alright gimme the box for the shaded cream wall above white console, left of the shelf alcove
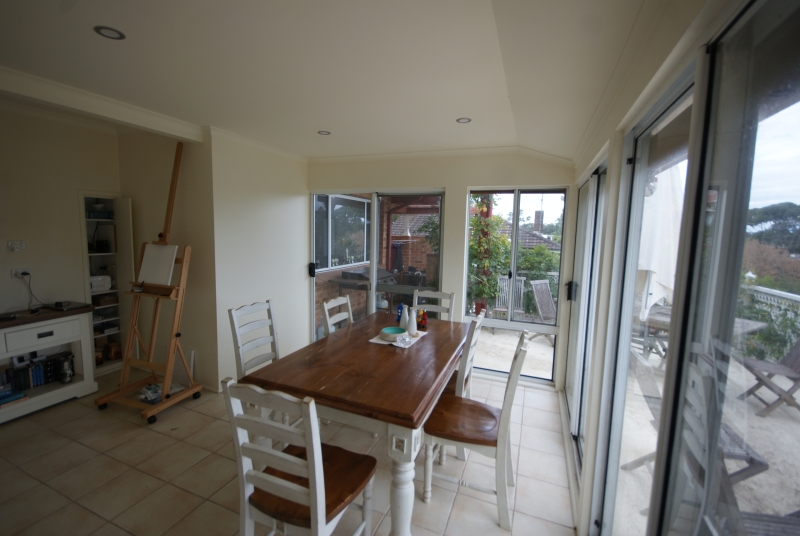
[0,103,120,311]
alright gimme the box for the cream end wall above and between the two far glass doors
[308,150,574,324]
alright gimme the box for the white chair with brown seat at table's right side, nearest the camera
[422,331,528,530]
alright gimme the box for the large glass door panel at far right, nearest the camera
[663,2,800,535]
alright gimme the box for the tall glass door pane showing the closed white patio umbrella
[606,95,692,536]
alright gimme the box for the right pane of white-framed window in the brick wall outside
[331,197,367,266]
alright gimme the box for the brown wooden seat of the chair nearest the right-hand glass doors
[425,395,501,447]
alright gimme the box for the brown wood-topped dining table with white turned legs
[241,312,469,536]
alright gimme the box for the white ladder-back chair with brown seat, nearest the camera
[222,378,377,536]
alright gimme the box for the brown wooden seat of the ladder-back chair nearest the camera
[249,443,378,528]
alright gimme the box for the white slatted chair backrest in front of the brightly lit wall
[228,300,280,379]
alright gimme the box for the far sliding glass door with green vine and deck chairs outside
[465,190,566,380]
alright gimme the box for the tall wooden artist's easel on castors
[94,142,203,424]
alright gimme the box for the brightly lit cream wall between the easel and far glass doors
[211,129,311,384]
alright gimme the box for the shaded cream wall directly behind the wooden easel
[119,129,219,390]
